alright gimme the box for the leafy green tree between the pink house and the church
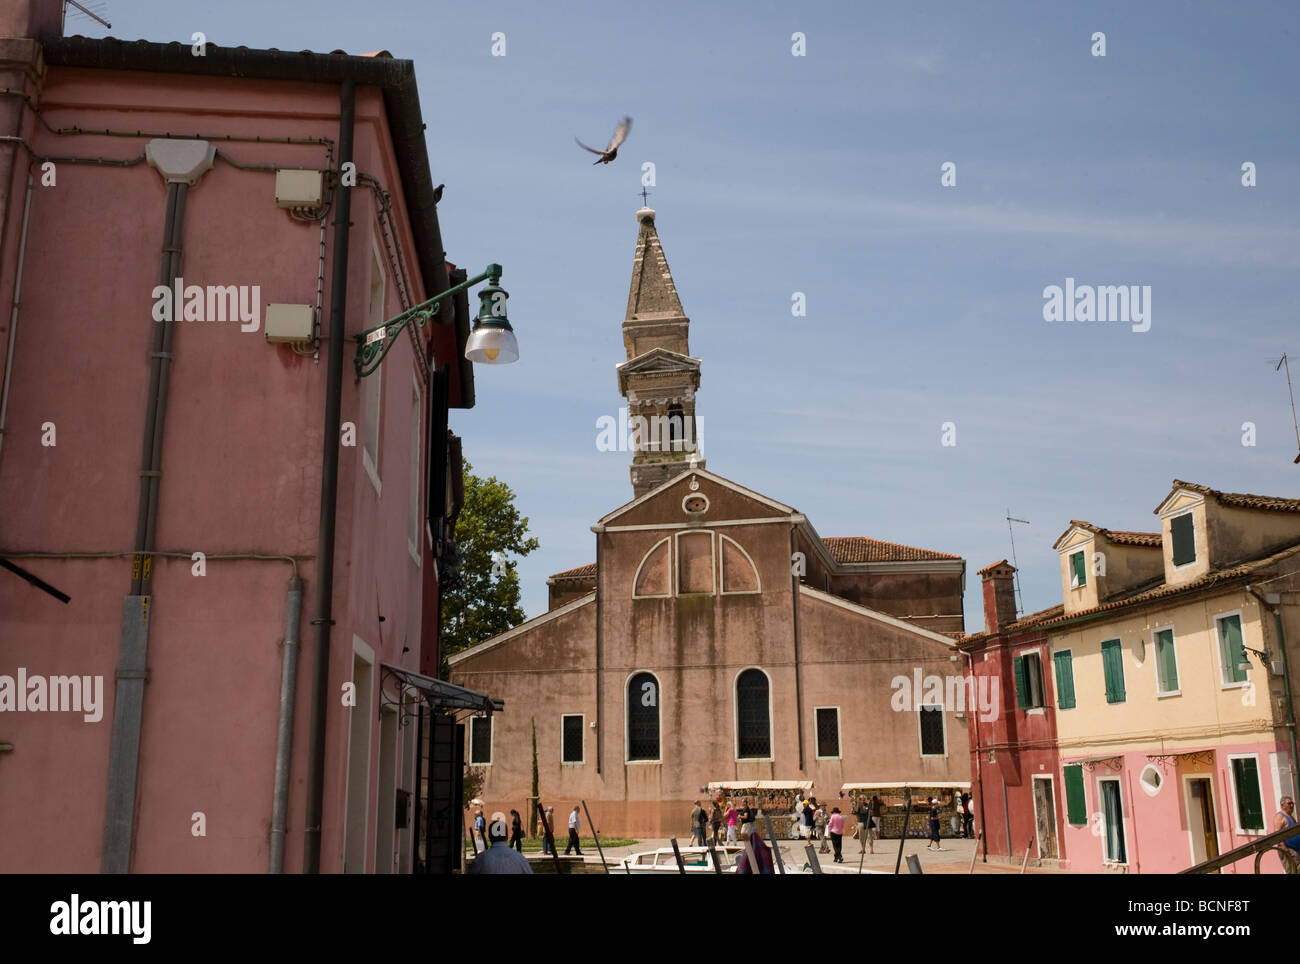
[442,461,538,659]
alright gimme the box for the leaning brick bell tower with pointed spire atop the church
[618,208,705,498]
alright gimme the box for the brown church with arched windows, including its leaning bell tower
[449,208,970,837]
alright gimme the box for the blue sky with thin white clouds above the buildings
[83,0,1300,631]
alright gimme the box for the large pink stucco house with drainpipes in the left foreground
[0,0,494,873]
